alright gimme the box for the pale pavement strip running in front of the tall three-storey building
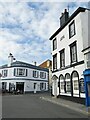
[41,95,90,118]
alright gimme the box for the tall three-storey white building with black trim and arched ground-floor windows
[50,7,90,101]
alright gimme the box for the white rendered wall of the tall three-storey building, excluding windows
[51,11,88,97]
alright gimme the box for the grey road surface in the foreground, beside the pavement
[2,94,87,118]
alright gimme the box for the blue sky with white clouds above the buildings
[0,0,87,66]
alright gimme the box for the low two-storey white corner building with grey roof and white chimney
[0,53,48,93]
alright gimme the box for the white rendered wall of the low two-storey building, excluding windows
[0,67,48,92]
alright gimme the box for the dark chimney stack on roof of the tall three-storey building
[60,9,69,27]
